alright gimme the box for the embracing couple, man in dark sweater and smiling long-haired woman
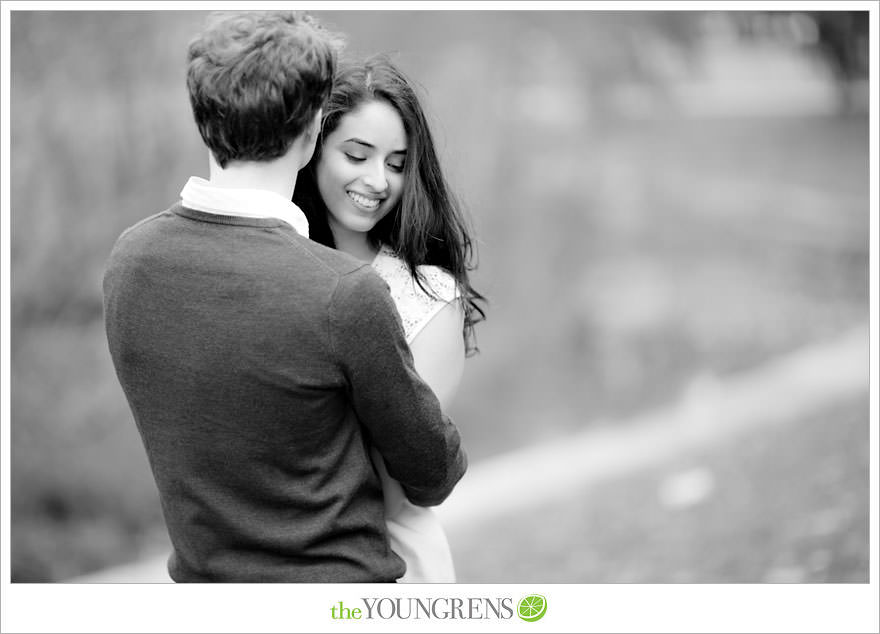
[104,12,483,582]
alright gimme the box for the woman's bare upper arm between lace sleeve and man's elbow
[410,301,464,411]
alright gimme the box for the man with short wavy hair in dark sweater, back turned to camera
[104,12,466,582]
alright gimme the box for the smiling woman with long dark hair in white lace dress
[293,57,485,583]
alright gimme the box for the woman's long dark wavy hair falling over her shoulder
[293,55,486,356]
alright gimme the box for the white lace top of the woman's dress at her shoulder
[373,245,461,343]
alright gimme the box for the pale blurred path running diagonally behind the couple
[72,325,869,583]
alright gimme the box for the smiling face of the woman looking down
[317,101,407,242]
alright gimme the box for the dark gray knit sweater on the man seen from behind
[104,205,466,582]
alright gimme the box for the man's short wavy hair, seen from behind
[186,11,342,167]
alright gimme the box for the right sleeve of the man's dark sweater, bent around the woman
[329,266,467,506]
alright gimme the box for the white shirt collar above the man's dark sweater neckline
[180,176,309,238]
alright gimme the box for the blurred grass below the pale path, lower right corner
[449,402,870,583]
